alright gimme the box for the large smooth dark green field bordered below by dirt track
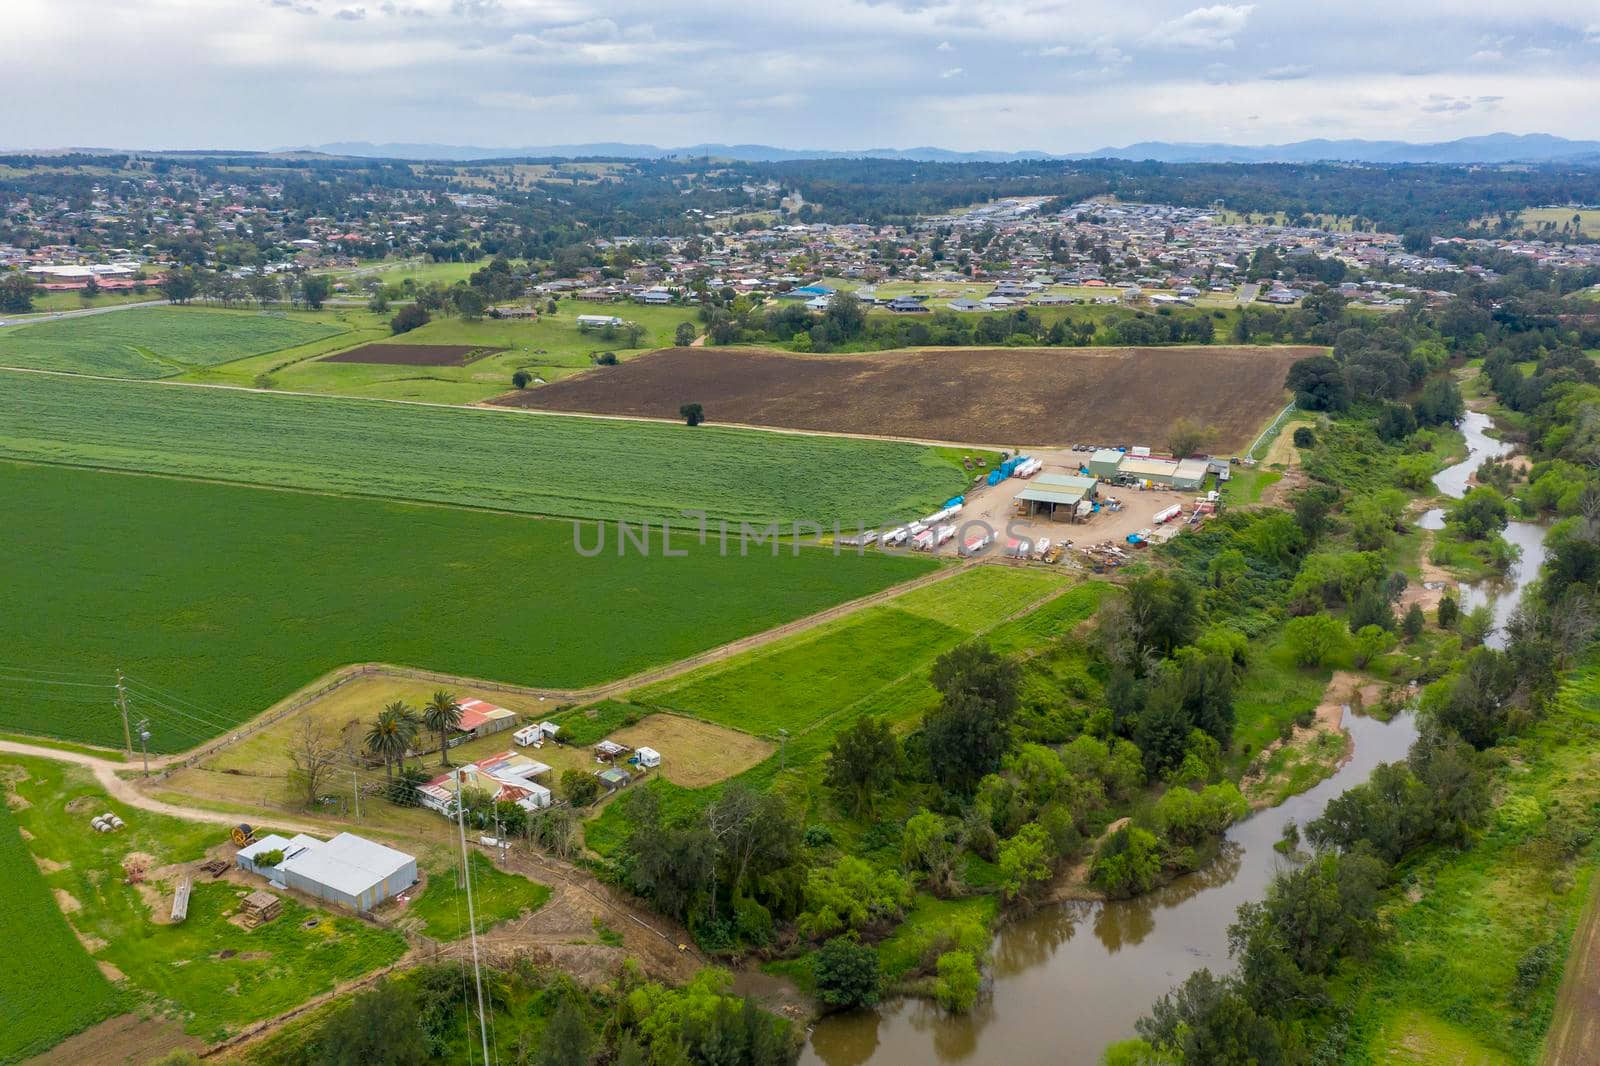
[0,464,938,751]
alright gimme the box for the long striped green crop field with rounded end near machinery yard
[0,373,966,521]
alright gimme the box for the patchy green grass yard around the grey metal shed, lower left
[4,759,406,1039]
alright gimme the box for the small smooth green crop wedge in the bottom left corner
[0,787,122,1063]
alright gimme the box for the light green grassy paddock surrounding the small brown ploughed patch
[182,300,694,403]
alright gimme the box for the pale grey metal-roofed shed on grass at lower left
[235,832,416,911]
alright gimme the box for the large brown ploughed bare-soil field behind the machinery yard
[493,346,1322,451]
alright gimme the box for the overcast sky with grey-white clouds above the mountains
[9,0,1600,152]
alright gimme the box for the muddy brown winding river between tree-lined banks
[800,403,1544,1066]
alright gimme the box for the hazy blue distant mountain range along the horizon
[302,133,1600,165]
